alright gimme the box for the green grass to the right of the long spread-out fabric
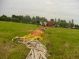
[45,28,79,59]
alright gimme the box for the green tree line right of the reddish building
[50,18,79,29]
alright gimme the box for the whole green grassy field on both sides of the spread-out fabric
[0,22,79,59]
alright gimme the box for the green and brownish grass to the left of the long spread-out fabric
[0,22,38,59]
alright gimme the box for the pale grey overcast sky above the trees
[0,0,79,24]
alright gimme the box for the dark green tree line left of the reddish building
[0,15,47,25]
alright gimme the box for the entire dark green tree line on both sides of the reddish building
[0,15,79,29]
